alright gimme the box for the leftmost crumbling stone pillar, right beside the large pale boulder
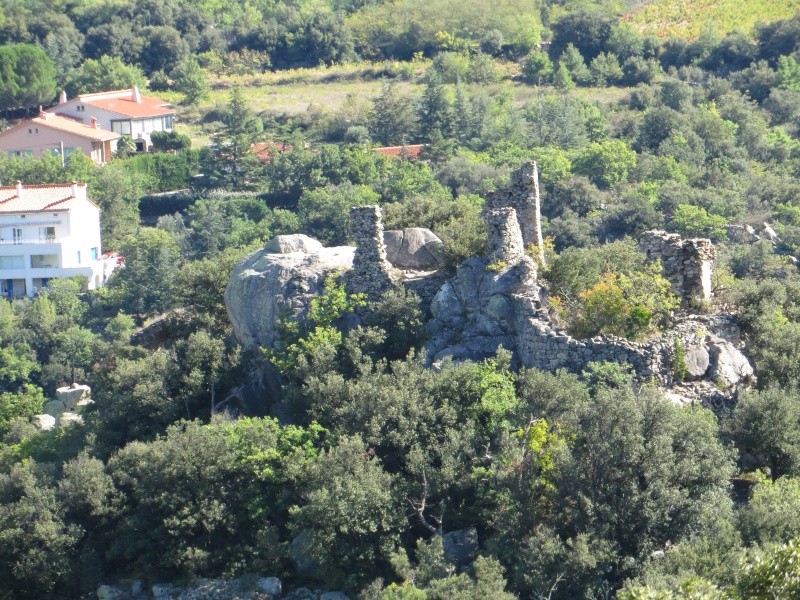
[346,206,392,298]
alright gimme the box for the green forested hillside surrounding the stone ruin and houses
[0,0,800,600]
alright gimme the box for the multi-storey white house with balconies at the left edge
[0,181,117,298]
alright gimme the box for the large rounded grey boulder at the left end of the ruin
[225,246,355,348]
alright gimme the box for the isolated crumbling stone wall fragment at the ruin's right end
[639,231,716,308]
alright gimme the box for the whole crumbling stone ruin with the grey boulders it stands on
[226,164,753,396]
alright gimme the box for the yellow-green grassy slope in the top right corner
[625,0,800,38]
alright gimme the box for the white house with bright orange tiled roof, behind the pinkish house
[47,86,175,152]
